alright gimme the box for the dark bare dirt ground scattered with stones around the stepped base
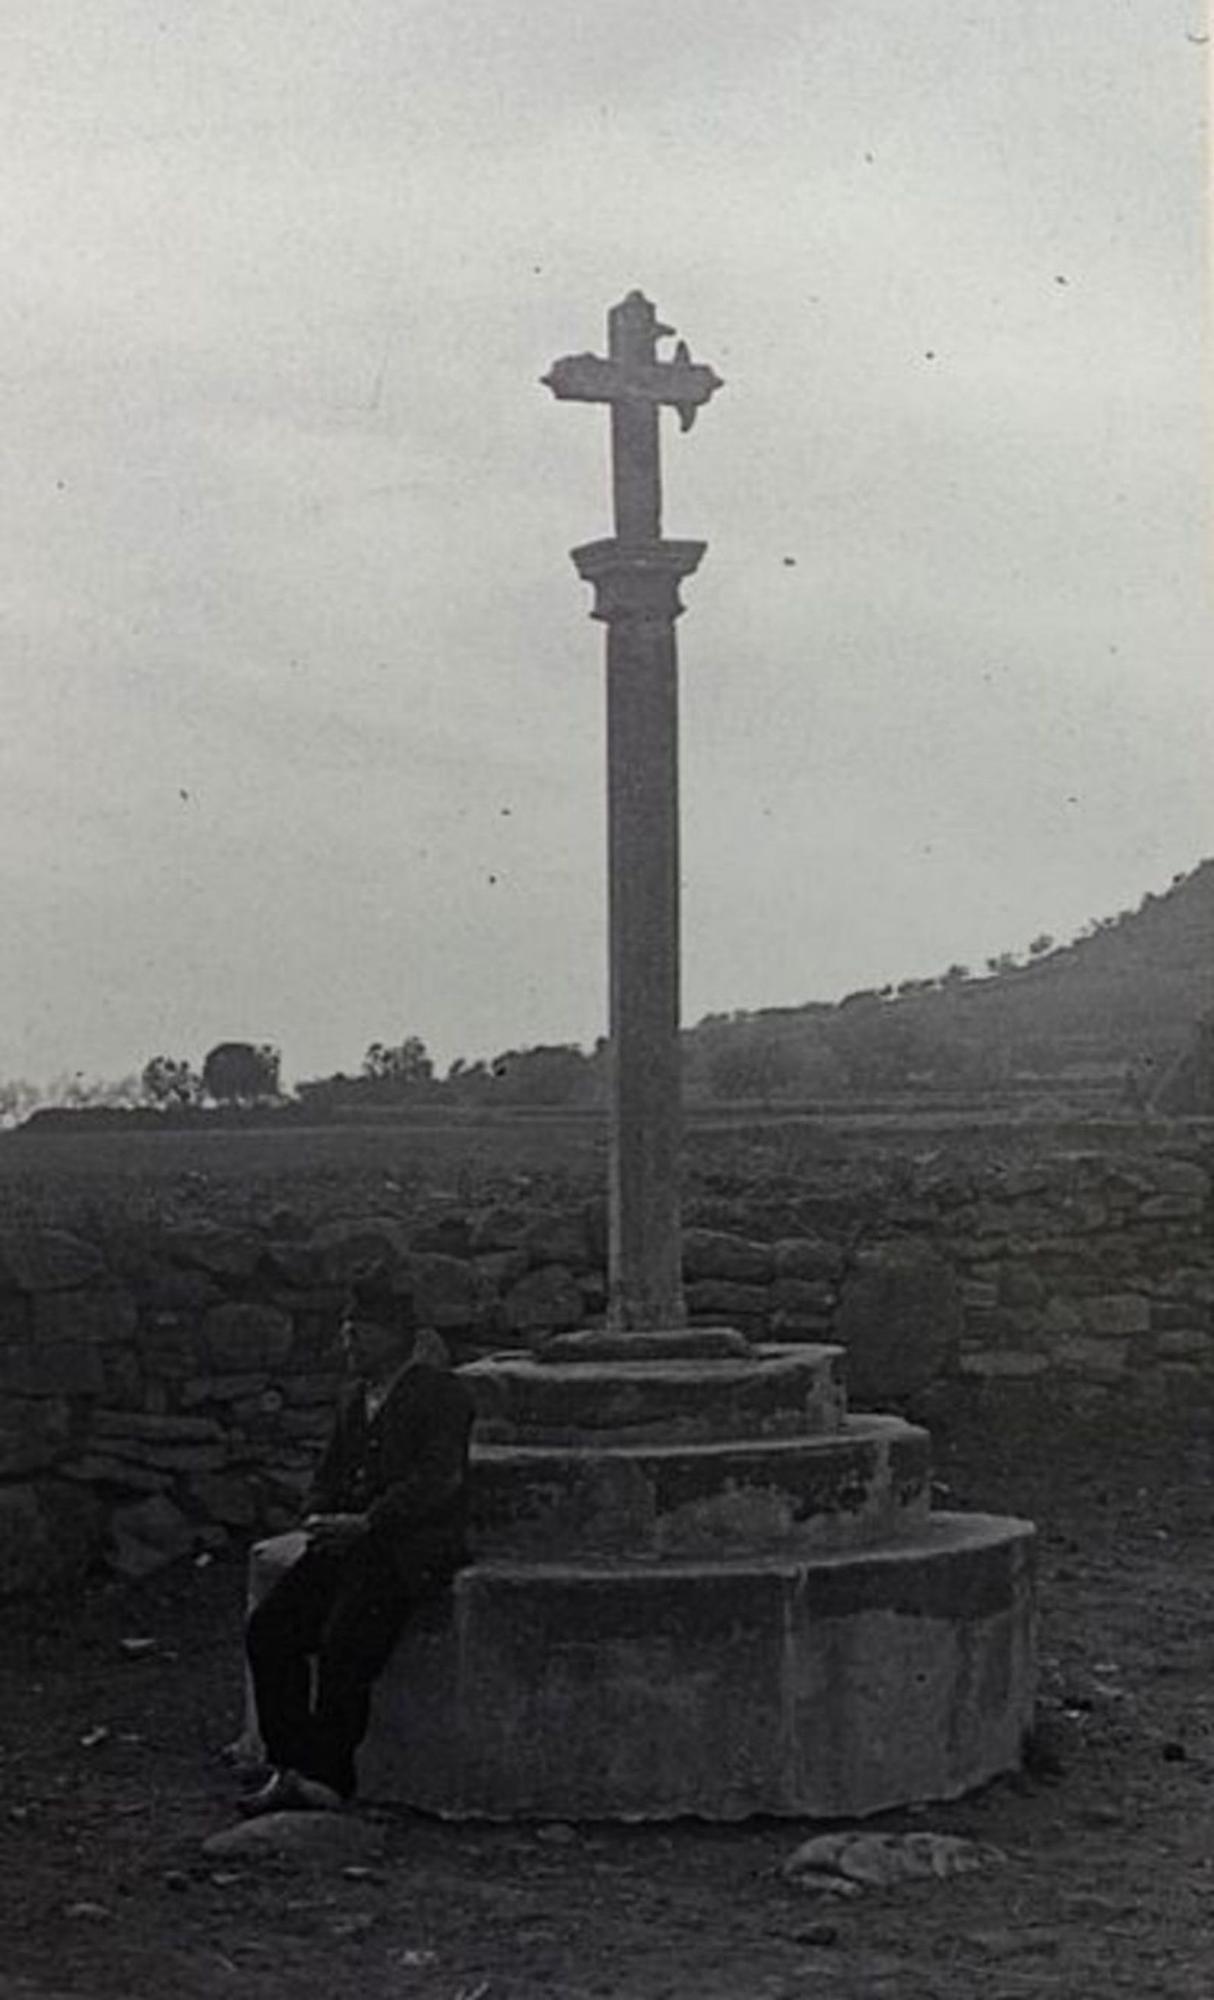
[0,1424,1214,2000]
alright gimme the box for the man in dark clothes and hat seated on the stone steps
[242,1276,474,1812]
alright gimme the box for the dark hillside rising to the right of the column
[688,860,1214,1096]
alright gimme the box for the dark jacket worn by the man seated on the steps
[308,1362,474,1580]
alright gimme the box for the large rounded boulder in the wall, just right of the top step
[834,1242,962,1406]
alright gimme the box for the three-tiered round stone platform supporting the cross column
[254,1328,1034,1820]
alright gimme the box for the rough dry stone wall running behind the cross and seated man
[0,1140,1214,1594]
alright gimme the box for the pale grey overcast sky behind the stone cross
[0,0,1214,1076]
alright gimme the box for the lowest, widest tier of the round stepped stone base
[360,1514,1034,1820]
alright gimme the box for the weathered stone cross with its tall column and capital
[544,292,722,1332]
